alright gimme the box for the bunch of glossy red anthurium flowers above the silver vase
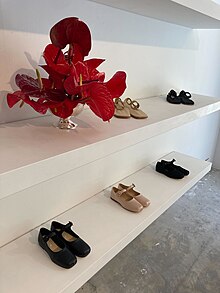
[7,17,126,121]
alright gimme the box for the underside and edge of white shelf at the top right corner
[91,0,220,29]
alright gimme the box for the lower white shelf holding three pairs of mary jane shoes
[0,152,211,293]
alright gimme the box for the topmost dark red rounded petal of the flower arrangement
[50,17,91,56]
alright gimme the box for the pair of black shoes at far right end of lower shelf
[156,159,189,179]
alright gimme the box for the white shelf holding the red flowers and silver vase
[0,95,220,199]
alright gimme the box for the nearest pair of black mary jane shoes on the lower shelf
[38,221,91,269]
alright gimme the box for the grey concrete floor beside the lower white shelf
[77,170,220,293]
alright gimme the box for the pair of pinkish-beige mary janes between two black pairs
[111,183,150,213]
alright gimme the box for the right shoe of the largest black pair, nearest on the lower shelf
[51,221,91,257]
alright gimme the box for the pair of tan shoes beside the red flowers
[114,98,148,119]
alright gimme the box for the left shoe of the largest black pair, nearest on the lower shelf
[38,228,77,269]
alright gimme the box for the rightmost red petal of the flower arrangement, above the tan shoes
[105,71,126,99]
